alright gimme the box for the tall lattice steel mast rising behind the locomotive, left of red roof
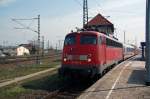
[83,0,88,28]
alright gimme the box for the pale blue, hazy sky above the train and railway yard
[0,0,146,46]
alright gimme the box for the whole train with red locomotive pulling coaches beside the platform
[58,31,135,78]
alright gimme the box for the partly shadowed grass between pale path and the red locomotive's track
[0,71,62,99]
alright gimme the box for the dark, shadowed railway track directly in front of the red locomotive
[42,81,93,99]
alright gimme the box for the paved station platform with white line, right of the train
[78,55,150,99]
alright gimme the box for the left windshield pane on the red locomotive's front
[64,35,76,45]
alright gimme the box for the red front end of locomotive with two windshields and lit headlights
[59,32,98,77]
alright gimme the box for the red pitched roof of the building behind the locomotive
[88,14,113,25]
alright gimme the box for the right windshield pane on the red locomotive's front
[80,35,97,44]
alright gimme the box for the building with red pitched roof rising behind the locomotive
[85,14,114,35]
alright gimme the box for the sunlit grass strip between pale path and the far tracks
[0,58,60,82]
